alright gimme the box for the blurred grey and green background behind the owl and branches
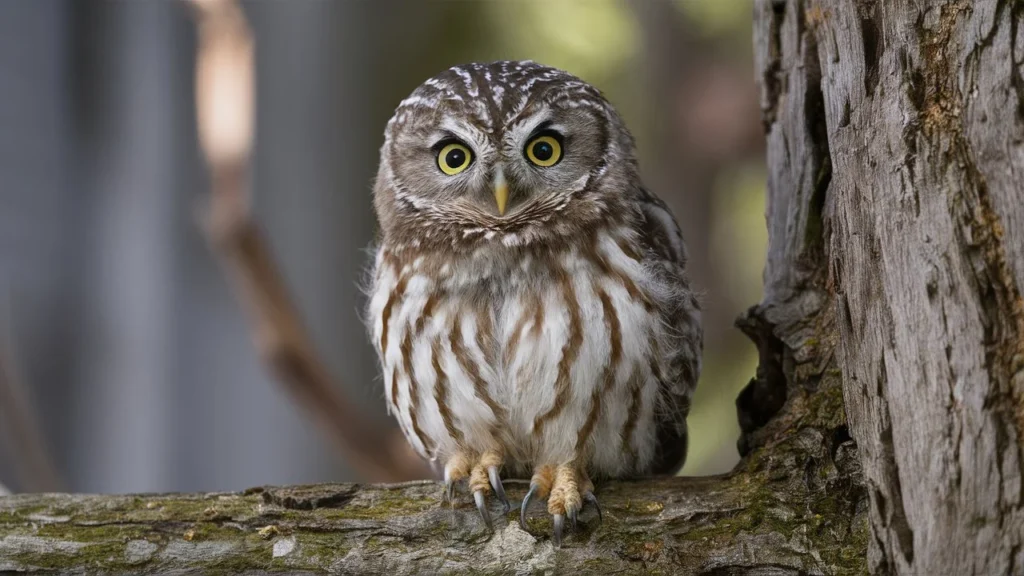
[0,0,766,492]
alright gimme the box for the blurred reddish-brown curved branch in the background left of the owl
[191,0,431,482]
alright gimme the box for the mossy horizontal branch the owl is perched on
[0,409,867,576]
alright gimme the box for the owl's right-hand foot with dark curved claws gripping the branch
[519,464,603,547]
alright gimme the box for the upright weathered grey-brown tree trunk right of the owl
[756,0,1024,574]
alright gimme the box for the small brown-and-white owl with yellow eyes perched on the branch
[367,61,702,545]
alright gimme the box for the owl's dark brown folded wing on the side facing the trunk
[640,186,703,475]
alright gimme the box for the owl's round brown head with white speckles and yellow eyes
[374,61,639,249]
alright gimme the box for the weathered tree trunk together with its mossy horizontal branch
[0,0,1024,575]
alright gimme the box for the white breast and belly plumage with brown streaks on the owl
[369,228,669,476]
